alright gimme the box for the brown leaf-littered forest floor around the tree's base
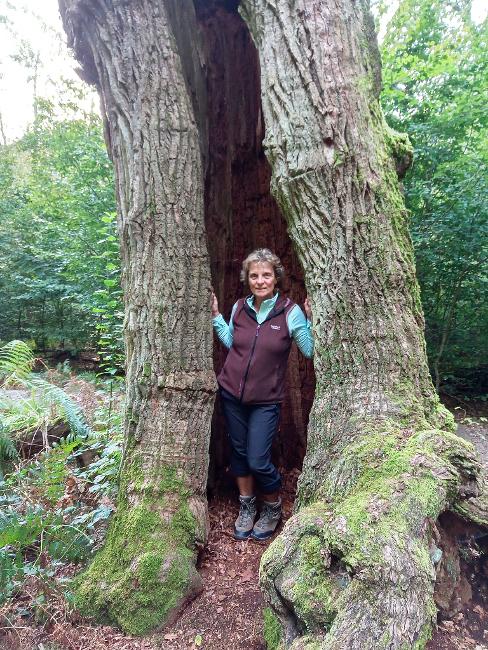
[0,404,488,650]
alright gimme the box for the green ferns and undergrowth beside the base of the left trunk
[0,350,122,627]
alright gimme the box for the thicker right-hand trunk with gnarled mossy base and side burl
[240,0,488,650]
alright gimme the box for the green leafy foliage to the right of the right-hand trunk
[382,0,488,393]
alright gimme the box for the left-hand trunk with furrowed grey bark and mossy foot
[60,0,216,633]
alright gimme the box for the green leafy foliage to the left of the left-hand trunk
[0,89,122,362]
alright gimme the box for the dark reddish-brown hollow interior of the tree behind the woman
[191,0,314,487]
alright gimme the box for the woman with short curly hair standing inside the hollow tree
[212,248,313,540]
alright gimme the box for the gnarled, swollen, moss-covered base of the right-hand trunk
[260,412,479,650]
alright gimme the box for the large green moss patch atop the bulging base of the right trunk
[312,425,457,572]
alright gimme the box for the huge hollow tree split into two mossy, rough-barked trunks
[60,0,487,650]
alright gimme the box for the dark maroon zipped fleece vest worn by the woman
[217,296,295,404]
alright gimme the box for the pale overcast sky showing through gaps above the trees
[0,0,488,141]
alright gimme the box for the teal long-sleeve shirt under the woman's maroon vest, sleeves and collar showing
[212,294,313,359]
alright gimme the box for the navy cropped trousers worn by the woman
[220,388,281,494]
